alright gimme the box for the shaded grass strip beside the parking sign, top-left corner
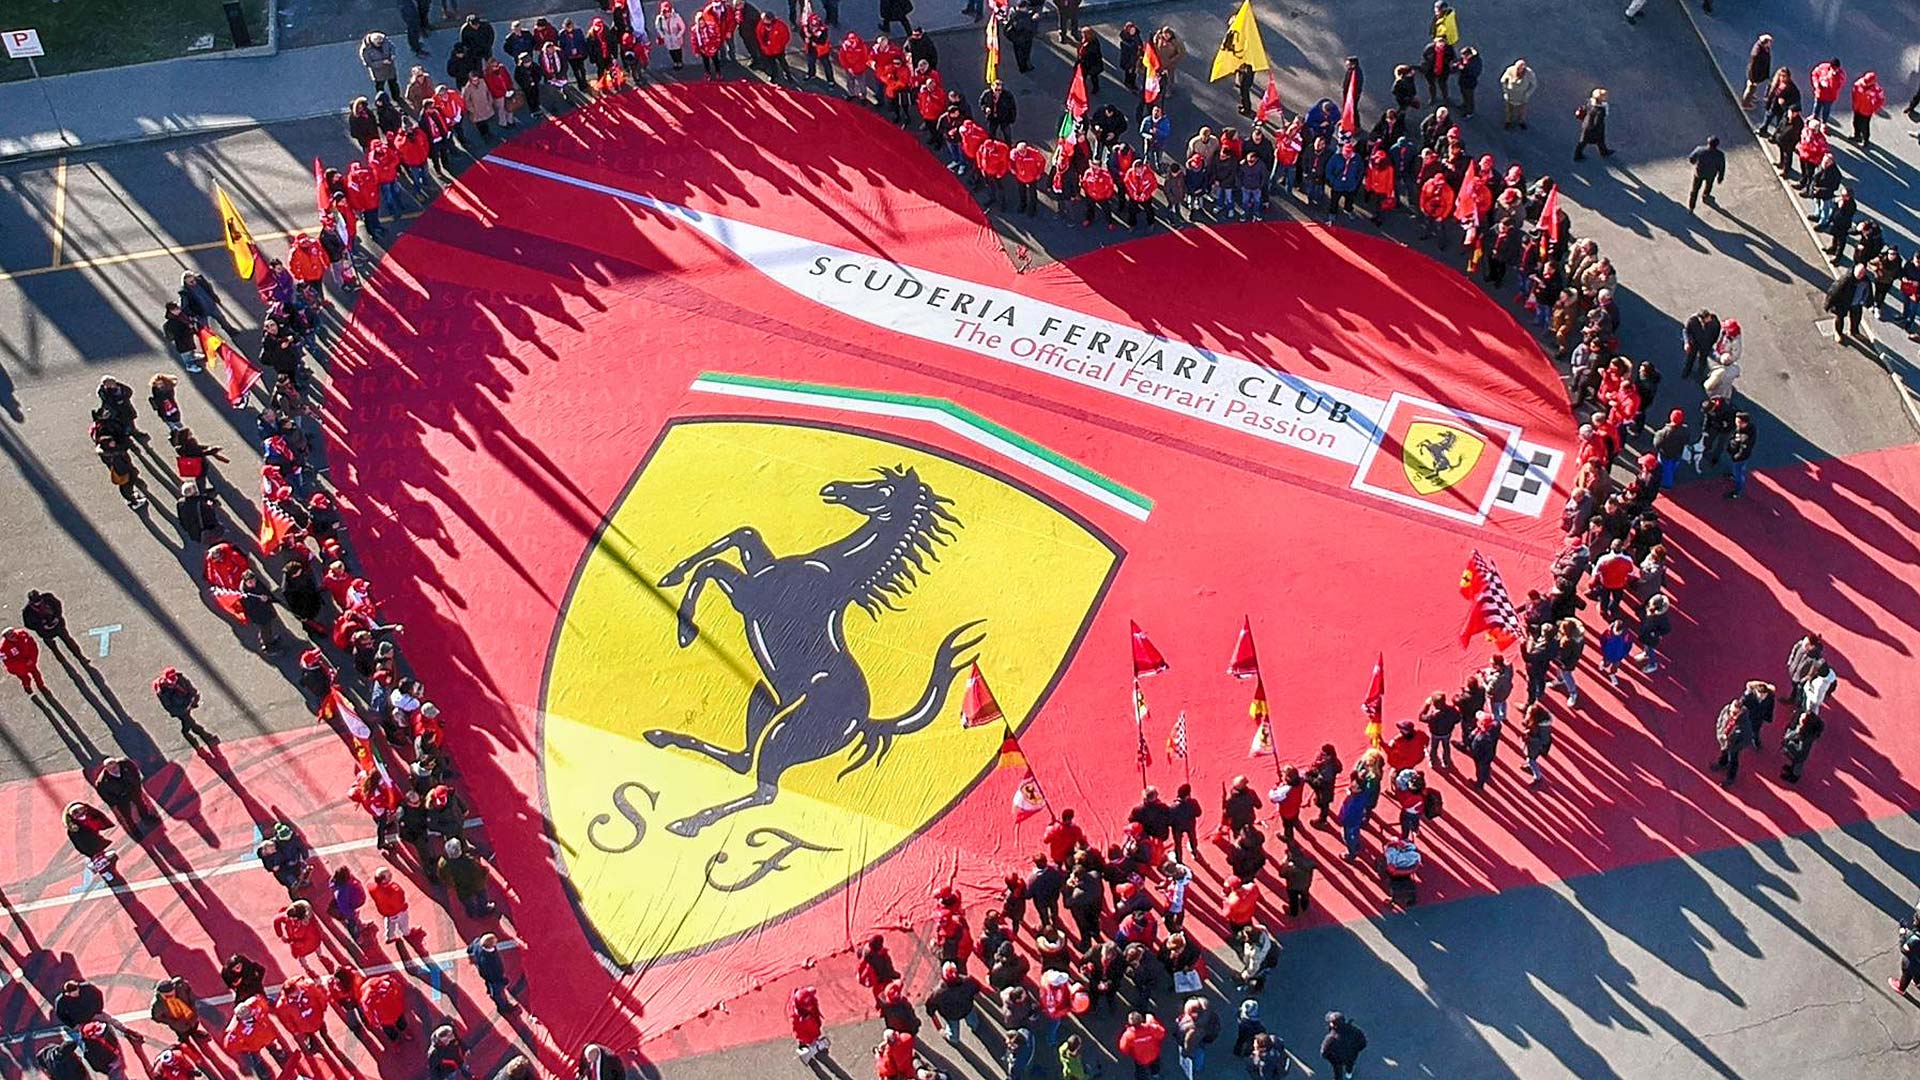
[0,0,278,83]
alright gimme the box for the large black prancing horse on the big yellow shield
[645,467,985,836]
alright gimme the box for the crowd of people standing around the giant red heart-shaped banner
[11,0,1920,1080]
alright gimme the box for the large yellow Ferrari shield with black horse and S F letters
[541,419,1119,965]
